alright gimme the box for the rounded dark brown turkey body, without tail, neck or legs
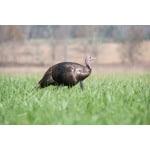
[52,62,91,86]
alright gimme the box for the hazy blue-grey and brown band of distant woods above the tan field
[0,25,150,43]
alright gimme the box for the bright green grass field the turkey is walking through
[0,74,150,125]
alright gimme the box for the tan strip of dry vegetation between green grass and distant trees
[0,40,150,73]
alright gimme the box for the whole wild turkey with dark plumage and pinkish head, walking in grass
[37,56,95,89]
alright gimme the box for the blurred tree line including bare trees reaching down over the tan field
[0,25,150,63]
